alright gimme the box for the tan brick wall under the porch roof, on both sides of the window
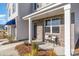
[33,15,64,46]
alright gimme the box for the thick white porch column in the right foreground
[64,4,71,56]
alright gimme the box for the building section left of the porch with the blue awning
[6,3,32,40]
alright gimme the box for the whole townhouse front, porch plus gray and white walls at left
[8,3,79,54]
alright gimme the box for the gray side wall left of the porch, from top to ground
[16,3,32,40]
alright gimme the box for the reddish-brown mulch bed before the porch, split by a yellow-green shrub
[15,43,56,56]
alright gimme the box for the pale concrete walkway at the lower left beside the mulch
[0,41,24,56]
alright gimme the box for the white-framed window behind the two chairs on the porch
[45,18,60,33]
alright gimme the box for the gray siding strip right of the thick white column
[71,3,79,49]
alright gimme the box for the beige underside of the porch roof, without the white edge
[32,8,64,20]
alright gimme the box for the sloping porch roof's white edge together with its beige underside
[23,5,64,20]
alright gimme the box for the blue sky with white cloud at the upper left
[0,3,8,24]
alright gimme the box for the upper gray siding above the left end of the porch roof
[18,3,32,18]
